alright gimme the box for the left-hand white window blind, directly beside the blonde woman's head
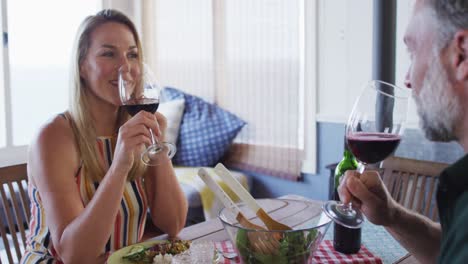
[153,0,215,102]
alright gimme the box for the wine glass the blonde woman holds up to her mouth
[118,64,176,166]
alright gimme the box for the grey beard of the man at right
[413,52,461,142]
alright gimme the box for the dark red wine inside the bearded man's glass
[346,132,401,164]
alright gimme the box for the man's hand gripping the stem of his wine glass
[338,171,398,226]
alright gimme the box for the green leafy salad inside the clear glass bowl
[236,229,320,264]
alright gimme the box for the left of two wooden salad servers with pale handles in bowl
[198,168,280,254]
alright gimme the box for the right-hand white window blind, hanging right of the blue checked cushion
[218,0,304,177]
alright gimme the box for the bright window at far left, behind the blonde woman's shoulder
[0,0,102,165]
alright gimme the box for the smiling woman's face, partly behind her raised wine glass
[80,22,139,106]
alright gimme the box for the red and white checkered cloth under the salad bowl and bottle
[215,240,382,264]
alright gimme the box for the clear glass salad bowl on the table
[218,199,331,264]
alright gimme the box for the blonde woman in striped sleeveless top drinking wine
[22,10,187,263]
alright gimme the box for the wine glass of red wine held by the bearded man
[323,80,410,228]
